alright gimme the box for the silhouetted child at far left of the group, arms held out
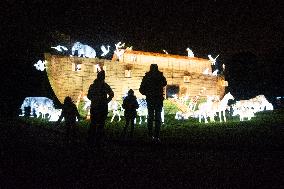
[56,96,81,142]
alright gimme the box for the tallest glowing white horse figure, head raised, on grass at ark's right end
[210,92,235,122]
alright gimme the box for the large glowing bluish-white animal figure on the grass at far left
[20,97,54,118]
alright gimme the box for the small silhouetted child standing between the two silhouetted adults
[122,89,139,138]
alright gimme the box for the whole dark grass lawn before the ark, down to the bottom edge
[0,110,284,188]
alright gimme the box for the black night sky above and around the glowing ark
[0,0,284,115]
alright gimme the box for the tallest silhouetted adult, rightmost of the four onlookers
[139,64,167,142]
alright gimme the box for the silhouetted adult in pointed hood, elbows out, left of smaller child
[87,70,114,148]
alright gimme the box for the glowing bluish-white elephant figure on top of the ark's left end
[72,42,96,58]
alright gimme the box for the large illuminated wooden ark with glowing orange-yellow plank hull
[45,49,227,112]
